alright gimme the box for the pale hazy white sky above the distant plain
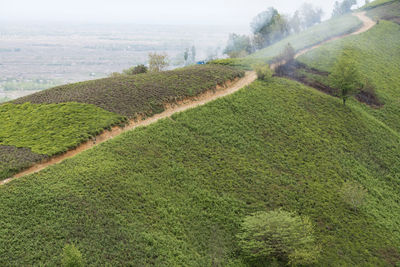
[0,0,364,25]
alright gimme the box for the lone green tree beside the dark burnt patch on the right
[329,50,360,105]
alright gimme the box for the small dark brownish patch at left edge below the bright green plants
[0,145,47,180]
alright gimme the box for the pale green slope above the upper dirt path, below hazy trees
[212,14,362,69]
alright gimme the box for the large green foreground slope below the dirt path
[0,78,400,266]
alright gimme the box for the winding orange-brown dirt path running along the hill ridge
[0,12,376,186]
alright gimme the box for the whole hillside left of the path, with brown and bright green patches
[0,66,244,180]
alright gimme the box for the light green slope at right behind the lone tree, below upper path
[299,21,400,133]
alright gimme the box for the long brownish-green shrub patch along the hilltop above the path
[14,65,244,117]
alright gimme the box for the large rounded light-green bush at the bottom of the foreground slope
[237,210,320,265]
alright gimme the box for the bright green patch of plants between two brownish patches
[0,103,125,155]
